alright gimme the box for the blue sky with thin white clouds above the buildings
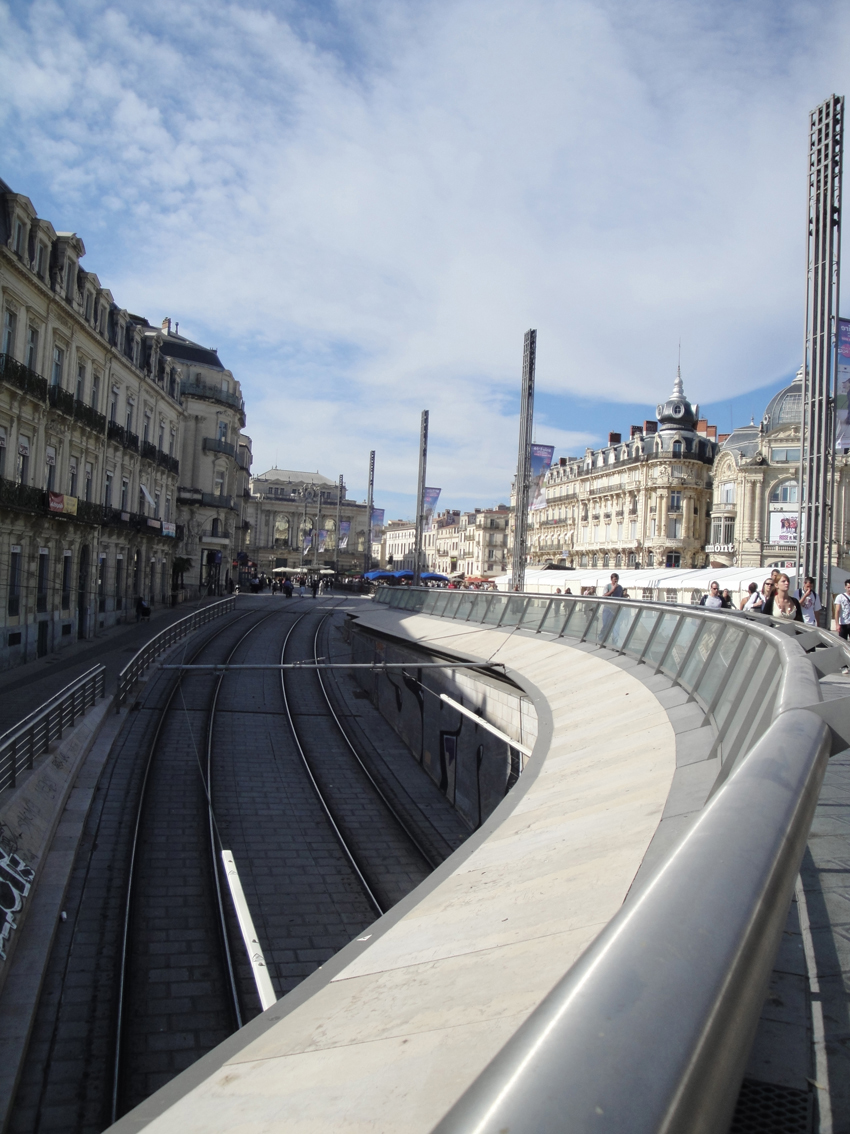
[0,0,850,518]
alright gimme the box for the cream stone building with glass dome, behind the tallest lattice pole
[707,372,850,569]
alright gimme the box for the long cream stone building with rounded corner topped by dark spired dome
[528,375,717,568]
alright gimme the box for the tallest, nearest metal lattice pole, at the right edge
[797,94,844,607]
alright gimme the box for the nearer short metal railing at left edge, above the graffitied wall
[0,666,107,792]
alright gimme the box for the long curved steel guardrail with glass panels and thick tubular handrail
[375,587,850,1134]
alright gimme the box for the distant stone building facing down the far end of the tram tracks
[246,468,368,575]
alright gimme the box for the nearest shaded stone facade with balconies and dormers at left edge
[0,183,182,667]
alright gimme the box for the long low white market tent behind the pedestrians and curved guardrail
[493,567,850,607]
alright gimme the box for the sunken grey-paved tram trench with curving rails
[9,598,469,1134]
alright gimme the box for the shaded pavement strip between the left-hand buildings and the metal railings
[0,598,230,736]
